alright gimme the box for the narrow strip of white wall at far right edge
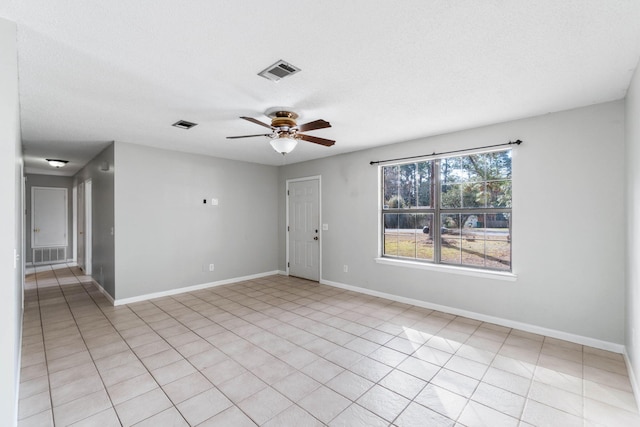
[625,60,640,404]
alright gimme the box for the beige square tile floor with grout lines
[19,265,640,427]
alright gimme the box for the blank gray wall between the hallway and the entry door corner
[115,142,278,299]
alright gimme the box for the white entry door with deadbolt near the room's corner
[288,179,320,281]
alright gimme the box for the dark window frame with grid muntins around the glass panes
[376,148,515,277]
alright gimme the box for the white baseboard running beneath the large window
[320,280,625,353]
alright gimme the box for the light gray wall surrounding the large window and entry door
[279,101,625,344]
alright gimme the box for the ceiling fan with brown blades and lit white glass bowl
[227,107,336,155]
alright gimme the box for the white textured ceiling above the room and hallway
[0,0,640,174]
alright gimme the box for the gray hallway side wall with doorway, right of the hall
[74,144,115,298]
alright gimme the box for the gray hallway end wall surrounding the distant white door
[24,174,75,263]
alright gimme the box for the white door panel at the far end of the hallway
[31,187,67,248]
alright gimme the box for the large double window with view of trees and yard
[381,150,512,271]
